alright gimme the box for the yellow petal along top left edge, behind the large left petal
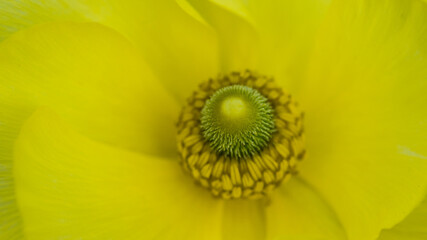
[0,0,221,101]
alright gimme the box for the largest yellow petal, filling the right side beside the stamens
[301,0,427,239]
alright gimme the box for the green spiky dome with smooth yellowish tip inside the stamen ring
[201,85,274,158]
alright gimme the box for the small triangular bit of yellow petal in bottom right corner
[378,195,427,240]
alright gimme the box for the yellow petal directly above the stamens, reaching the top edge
[189,0,330,95]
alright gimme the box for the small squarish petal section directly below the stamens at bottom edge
[222,199,266,240]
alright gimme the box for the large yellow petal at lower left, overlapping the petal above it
[14,109,222,240]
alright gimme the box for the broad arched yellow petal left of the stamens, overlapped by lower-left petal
[0,23,177,239]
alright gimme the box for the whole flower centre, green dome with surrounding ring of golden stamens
[177,71,305,199]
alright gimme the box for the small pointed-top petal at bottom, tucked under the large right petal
[266,177,346,240]
